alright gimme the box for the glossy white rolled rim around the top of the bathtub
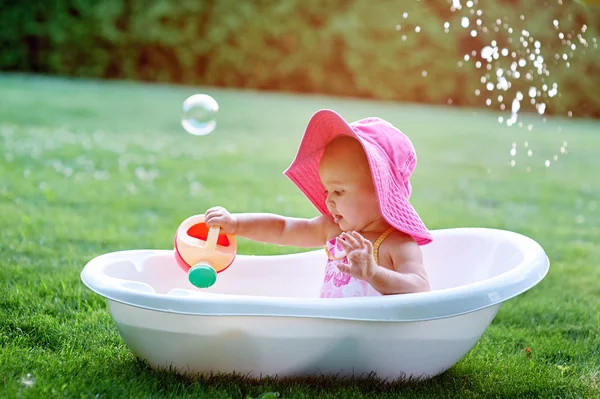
[80,227,550,322]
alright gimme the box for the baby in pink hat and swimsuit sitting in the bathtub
[205,110,432,298]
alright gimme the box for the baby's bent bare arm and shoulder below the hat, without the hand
[369,236,431,295]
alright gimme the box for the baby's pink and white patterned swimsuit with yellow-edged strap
[321,228,394,298]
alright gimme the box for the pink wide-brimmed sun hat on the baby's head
[283,110,433,245]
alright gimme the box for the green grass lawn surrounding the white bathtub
[0,75,600,398]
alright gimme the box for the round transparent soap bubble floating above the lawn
[181,94,219,136]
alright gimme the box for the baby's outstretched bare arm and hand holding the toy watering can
[205,207,339,248]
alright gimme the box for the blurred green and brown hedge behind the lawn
[0,0,600,117]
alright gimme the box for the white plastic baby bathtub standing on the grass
[81,228,549,379]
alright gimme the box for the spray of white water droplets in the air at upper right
[396,0,598,171]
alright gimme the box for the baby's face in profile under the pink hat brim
[319,139,381,231]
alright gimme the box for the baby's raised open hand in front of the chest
[338,231,379,281]
